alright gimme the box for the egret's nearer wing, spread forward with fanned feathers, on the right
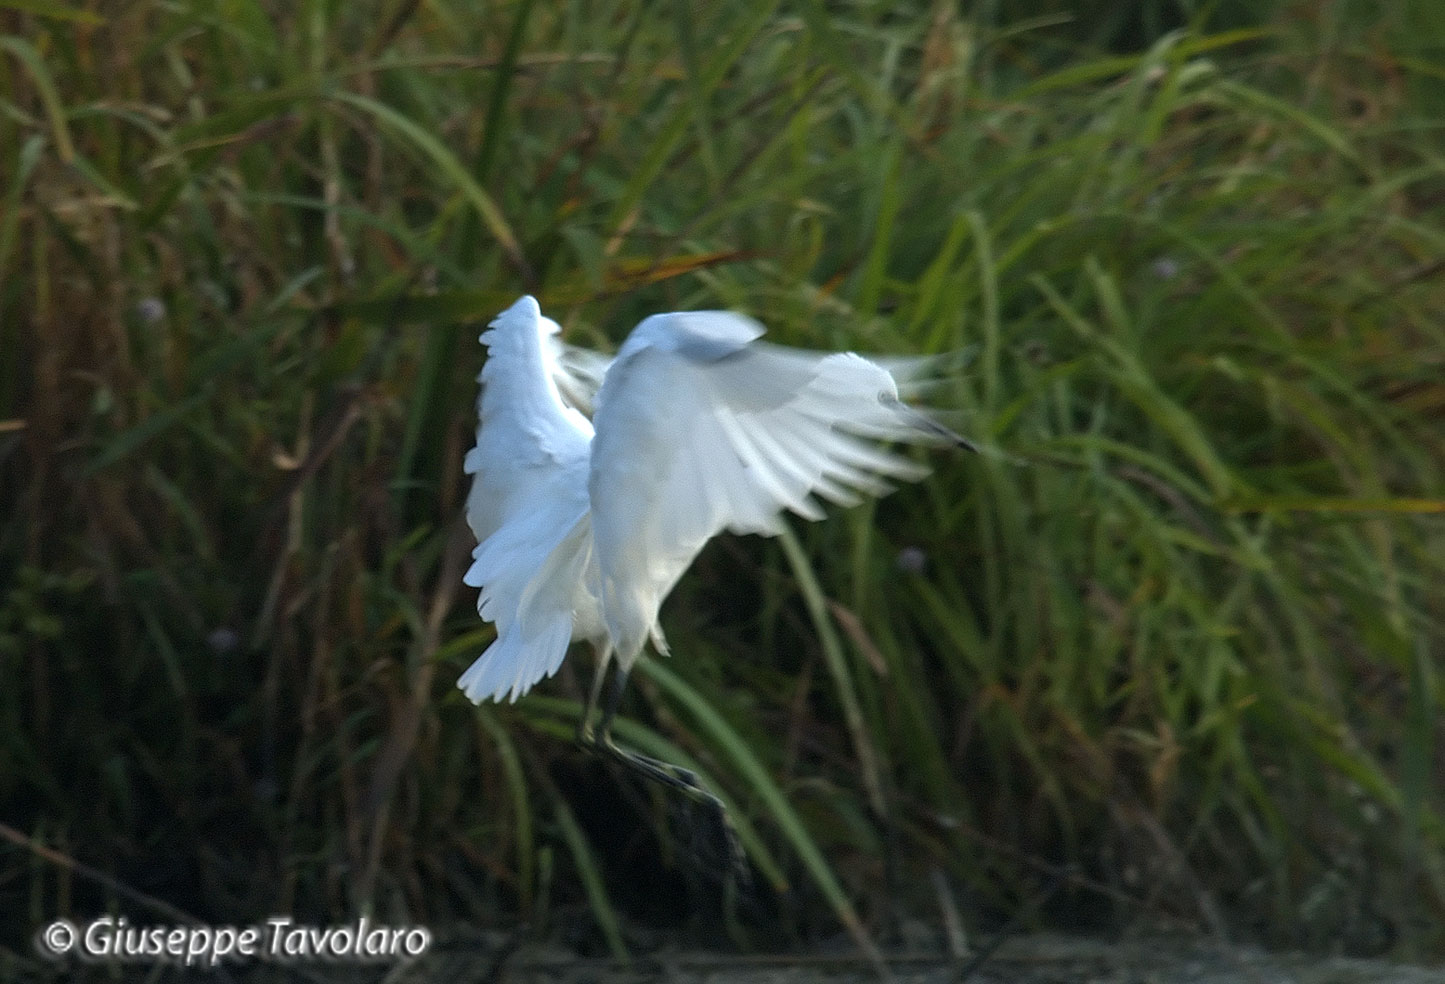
[588,312,939,656]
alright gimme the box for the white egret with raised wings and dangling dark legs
[458,296,972,872]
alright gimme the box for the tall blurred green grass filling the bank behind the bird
[0,0,1445,965]
